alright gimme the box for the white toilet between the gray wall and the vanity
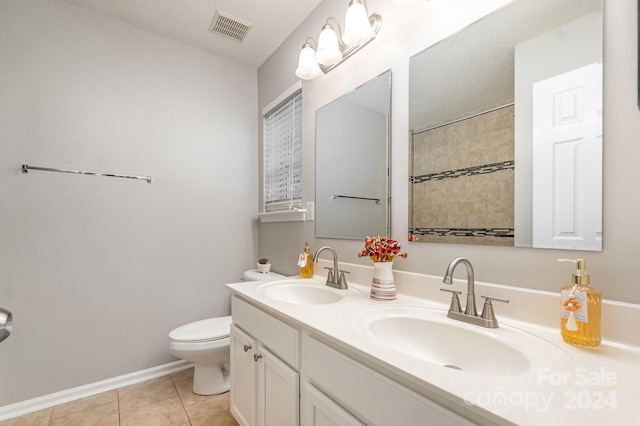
[169,269,284,395]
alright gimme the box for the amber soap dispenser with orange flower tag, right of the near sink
[558,259,602,348]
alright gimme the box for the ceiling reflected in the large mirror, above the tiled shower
[409,0,602,130]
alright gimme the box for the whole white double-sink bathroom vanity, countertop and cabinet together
[228,265,640,425]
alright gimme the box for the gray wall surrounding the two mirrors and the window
[258,0,640,303]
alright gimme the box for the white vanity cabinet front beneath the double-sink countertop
[231,296,472,426]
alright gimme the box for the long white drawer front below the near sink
[303,336,471,426]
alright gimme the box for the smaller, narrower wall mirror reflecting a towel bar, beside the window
[316,71,391,239]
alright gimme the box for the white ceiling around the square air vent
[67,0,321,68]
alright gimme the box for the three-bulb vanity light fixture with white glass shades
[296,0,382,80]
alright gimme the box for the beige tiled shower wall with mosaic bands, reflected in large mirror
[409,105,514,246]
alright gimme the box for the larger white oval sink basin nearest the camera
[354,306,570,376]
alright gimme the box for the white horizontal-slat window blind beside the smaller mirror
[263,89,302,212]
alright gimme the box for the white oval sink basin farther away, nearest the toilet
[256,279,356,305]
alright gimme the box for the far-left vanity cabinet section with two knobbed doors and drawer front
[230,297,300,426]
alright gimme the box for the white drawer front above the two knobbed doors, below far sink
[231,296,300,370]
